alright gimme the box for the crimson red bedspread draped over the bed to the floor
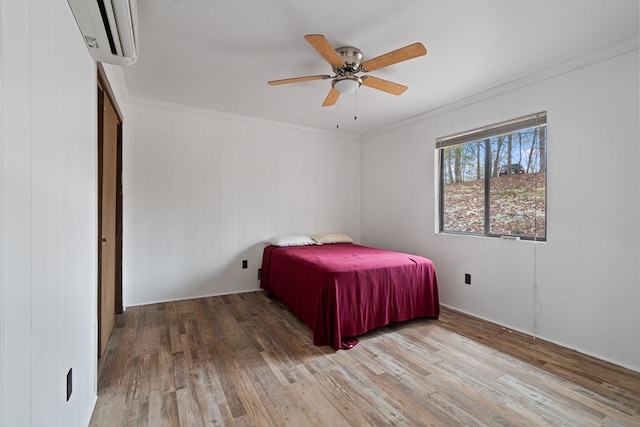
[260,243,440,350]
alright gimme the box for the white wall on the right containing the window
[362,43,640,370]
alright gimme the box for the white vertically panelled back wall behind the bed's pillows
[123,100,360,306]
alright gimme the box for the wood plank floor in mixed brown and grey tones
[90,291,640,427]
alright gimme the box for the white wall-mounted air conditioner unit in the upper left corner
[67,0,138,65]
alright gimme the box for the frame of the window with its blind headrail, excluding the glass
[436,111,548,242]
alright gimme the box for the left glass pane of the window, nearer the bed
[441,141,485,233]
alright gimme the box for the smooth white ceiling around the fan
[123,0,639,134]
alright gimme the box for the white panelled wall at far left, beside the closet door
[0,0,97,427]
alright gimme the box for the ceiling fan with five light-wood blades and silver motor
[268,34,427,107]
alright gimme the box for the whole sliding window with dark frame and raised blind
[436,112,547,240]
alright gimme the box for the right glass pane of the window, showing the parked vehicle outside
[489,126,546,238]
